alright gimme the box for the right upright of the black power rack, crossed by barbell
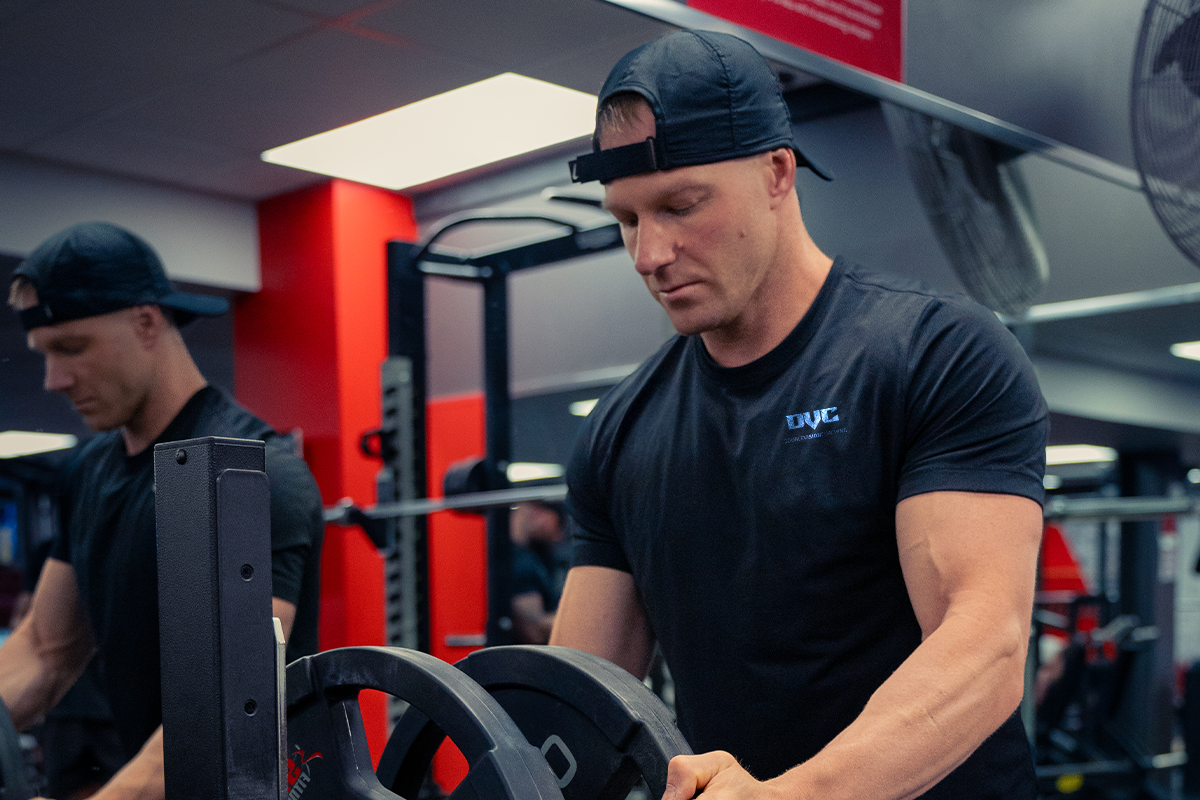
[482,267,512,645]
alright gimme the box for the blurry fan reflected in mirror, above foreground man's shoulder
[881,103,1050,314]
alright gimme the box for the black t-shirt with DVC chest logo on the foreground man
[568,259,1046,800]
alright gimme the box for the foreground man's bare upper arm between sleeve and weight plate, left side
[550,566,654,678]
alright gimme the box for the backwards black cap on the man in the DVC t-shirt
[570,30,833,184]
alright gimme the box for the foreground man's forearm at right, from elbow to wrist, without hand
[770,608,1027,800]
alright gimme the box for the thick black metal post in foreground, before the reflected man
[154,437,280,800]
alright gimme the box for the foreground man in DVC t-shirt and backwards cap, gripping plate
[552,31,1046,800]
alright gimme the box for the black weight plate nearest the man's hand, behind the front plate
[379,645,691,800]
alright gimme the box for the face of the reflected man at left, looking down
[26,308,154,431]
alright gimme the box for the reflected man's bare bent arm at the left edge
[0,559,96,730]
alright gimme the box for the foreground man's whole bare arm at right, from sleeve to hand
[665,492,1042,800]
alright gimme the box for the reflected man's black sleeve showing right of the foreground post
[266,437,324,603]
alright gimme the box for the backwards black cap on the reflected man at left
[12,222,229,331]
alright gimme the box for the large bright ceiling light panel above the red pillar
[263,72,596,190]
